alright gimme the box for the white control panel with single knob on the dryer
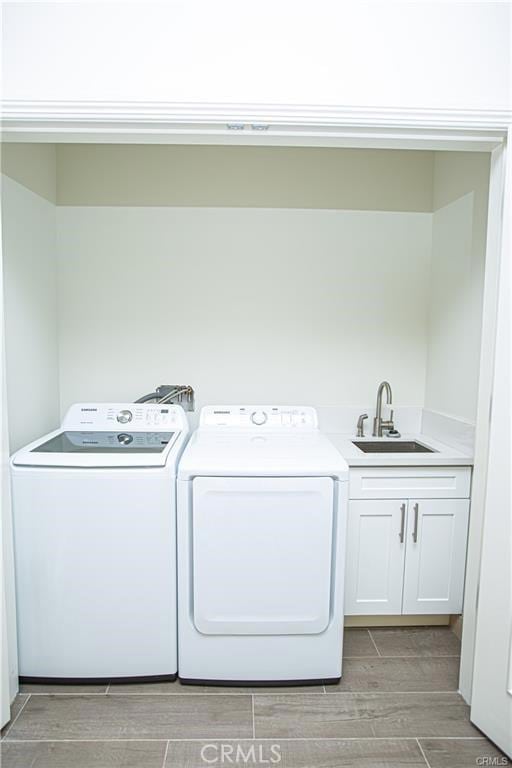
[199,405,318,430]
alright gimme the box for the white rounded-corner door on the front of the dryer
[192,477,335,635]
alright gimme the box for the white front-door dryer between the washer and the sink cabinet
[177,406,348,685]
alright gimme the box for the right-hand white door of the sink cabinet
[402,499,469,613]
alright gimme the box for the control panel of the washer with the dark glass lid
[62,403,187,433]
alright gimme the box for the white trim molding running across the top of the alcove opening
[1,101,512,152]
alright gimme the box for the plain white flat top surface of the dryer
[178,429,348,480]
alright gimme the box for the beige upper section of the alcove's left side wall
[0,143,57,203]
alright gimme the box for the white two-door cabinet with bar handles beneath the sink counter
[345,467,471,616]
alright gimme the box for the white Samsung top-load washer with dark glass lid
[11,403,189,682]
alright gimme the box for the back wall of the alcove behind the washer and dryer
[53,144,434,420]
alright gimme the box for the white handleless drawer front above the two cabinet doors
[350,467,471,499]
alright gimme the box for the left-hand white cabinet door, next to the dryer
[345,499,407,616]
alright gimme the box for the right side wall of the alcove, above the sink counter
[425,152,490,423]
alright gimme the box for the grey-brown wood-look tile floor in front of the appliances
[1,627,512,768]
